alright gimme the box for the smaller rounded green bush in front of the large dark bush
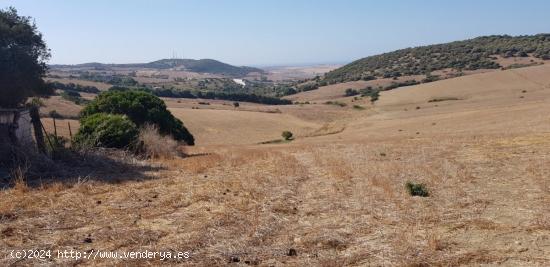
[74,113,138,148]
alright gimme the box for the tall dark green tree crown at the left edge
[0,7,53,108]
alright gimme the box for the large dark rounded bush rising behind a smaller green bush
[81,90,195,145]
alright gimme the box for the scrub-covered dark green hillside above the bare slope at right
[324,34,550,83]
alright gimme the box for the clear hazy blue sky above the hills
[4,0,550,65]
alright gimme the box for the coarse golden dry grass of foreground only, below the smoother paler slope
[0,136,550,266]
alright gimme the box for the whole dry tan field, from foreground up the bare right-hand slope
[0,64,550,266]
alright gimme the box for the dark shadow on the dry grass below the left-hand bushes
[0,149,164,189]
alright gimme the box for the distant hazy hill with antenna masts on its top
[50,59,264,77]
